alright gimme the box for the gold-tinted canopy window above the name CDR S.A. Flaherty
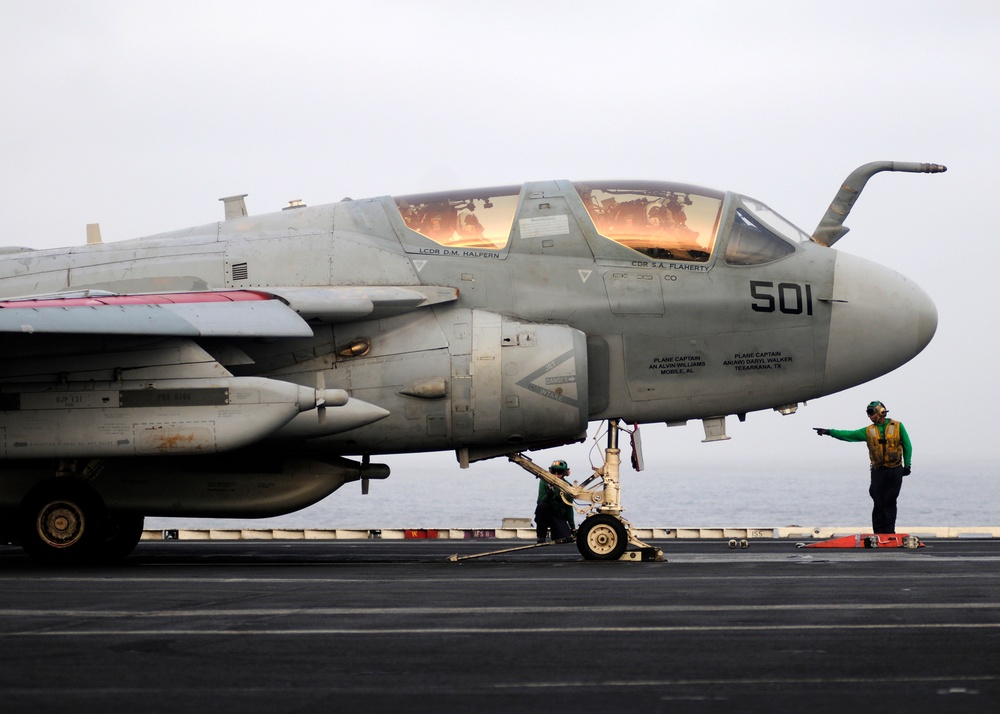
[574,181,725,263]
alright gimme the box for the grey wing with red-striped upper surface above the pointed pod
[0,286,458,337]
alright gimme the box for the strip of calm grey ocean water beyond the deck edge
[146,453,1000,529]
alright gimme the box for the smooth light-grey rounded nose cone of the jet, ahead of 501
[826,253,937,391]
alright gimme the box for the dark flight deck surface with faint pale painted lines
[0,539,1000,714]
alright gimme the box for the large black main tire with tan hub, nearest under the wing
[19,477,107,564]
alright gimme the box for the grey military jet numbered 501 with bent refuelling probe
[0,162,945,562]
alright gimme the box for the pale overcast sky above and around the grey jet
[0,0,1000,469]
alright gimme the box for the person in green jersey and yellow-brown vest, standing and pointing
[816,402,913,533]
